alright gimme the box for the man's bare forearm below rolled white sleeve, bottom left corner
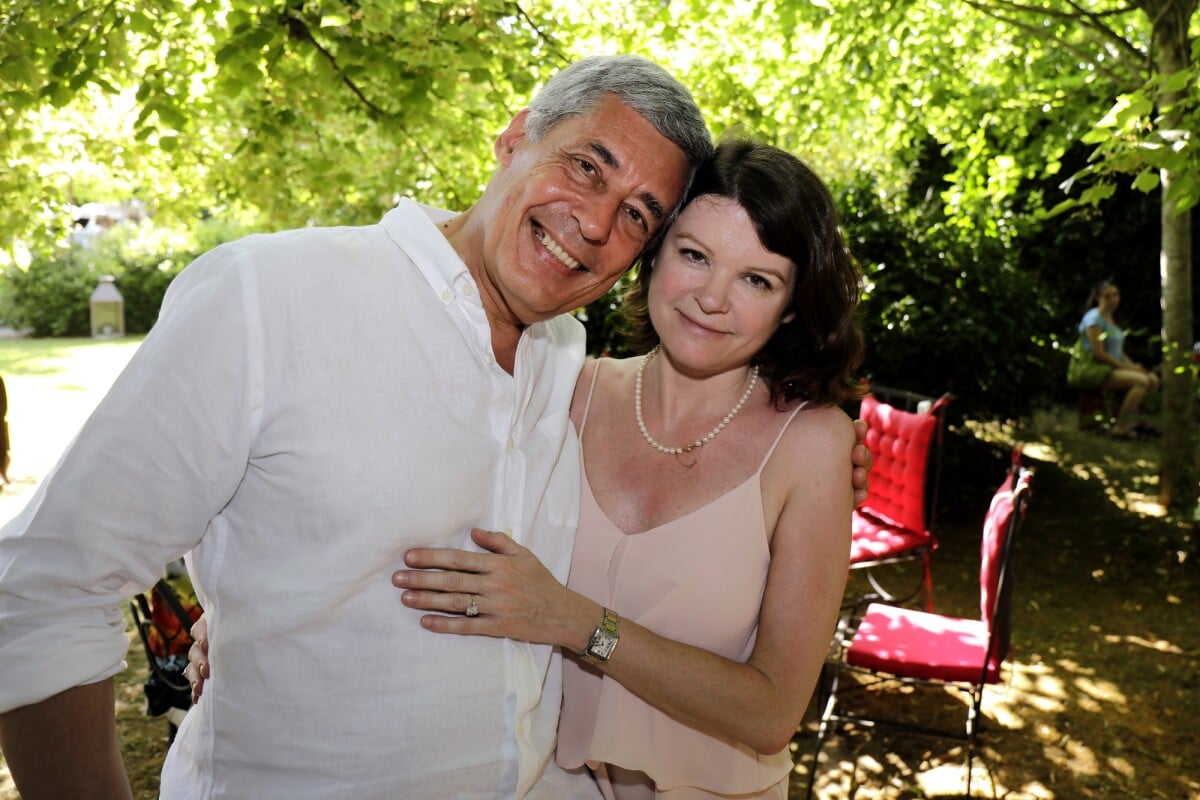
[0,679,133,800]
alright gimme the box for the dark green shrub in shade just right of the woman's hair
[838,170,1066,419]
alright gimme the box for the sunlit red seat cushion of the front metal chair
[846,603,1001,684]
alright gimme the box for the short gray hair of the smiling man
[526,55,713,184]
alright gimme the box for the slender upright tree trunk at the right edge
[1154,1,1198,509]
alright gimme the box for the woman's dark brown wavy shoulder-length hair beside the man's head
[624,139,865,408]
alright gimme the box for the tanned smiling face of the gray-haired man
[464,96,688,326]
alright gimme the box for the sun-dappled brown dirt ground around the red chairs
[0,409,1200,800]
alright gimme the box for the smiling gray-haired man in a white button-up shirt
[0,56,712,800]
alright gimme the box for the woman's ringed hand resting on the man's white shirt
[391,528,604,651]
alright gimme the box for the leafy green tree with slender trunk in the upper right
[782,0,1200,507]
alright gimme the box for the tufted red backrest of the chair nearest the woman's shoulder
[858,395,941,533]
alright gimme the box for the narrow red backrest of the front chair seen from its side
[979,460,1033,676]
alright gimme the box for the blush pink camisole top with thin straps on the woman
[557,360,803,794]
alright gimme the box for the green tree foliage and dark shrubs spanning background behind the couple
[0,0,1200,503]
